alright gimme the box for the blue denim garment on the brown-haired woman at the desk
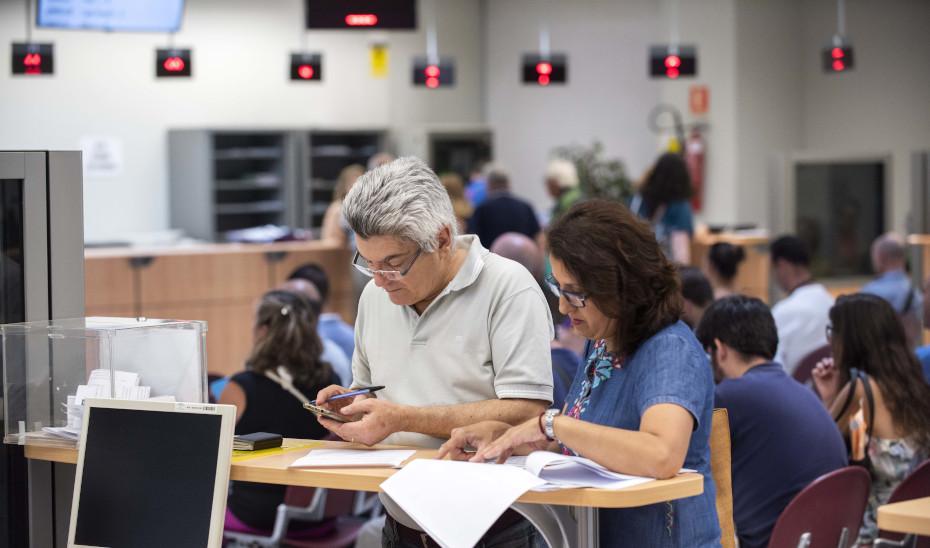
[565,321,720,547]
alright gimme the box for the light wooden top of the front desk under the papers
[25,439,704,508]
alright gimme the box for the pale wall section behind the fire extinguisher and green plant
[485,0,736,222]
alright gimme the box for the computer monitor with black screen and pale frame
[68,399,236,548]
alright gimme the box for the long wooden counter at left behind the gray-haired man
[84,242,355,375]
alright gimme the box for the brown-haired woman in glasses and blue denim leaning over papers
[439,200,720,548]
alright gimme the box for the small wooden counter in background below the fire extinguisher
[691,232,771,303]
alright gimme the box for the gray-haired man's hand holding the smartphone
[317,396,410,445]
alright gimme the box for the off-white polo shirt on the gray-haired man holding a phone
[352,235,553,447]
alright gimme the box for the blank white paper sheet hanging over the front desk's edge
[381,459,545,548]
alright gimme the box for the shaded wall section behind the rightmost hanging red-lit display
[801,0,930,231]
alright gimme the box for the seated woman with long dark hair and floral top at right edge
[812,293,930,546]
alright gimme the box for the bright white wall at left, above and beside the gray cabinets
[0,0,483,240]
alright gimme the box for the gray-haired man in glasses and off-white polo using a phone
[316,157,553,547]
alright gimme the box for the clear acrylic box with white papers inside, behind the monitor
[0,317,207,445]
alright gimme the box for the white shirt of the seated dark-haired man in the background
[772,283,833,375]
